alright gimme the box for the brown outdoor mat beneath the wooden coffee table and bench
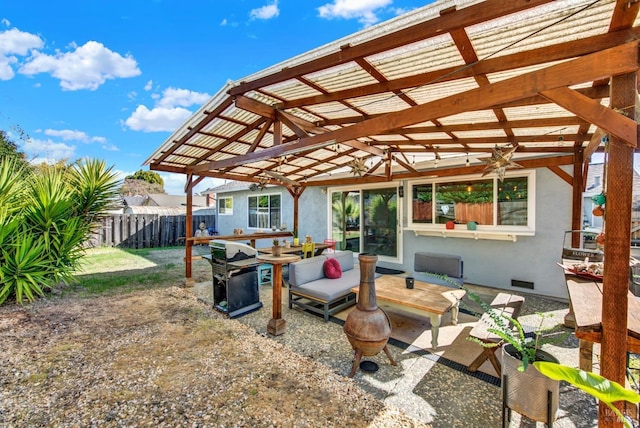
[331,302,500,385]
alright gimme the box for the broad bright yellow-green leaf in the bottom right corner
[533,361,640,428]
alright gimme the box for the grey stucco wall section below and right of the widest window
[401,168,572,299]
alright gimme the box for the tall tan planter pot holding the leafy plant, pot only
[502,344,560,423]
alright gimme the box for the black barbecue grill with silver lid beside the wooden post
[204,239,262,318]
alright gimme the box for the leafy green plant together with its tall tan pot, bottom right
[467,290,566,423]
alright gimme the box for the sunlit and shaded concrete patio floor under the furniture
[191,281,599,428]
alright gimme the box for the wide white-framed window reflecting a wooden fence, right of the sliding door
[408,171,535,231]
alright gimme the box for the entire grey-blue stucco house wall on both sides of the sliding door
[212,168,572,299]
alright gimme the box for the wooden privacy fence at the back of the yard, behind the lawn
[88,214,215,248]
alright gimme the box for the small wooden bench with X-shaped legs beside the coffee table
[467,293,524,376]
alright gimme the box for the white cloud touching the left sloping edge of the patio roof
[124,88,210,132]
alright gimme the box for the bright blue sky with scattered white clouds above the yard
[0,0,428,194]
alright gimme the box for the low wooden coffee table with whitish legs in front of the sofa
[351,275,466,350]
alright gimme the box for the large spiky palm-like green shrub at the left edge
[0,158,118,304]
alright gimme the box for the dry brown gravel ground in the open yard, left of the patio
[0,287,430,427]
